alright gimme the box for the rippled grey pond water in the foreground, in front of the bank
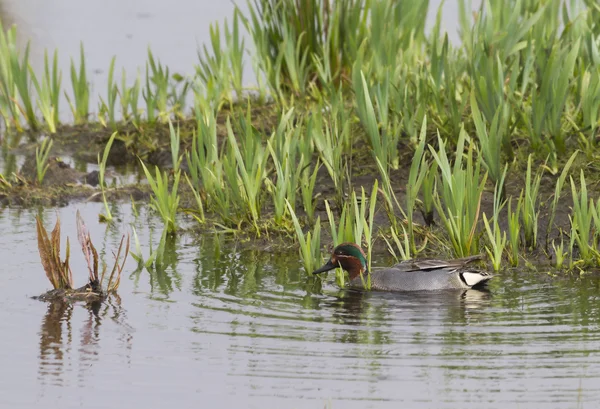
[0,203,600,409]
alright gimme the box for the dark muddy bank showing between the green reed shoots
[0,106,600,263]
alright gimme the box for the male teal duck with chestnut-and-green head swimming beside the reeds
[313,243,493,291]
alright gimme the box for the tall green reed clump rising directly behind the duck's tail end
[429,128,487,257]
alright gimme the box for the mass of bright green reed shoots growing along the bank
[0,0,600,279]
